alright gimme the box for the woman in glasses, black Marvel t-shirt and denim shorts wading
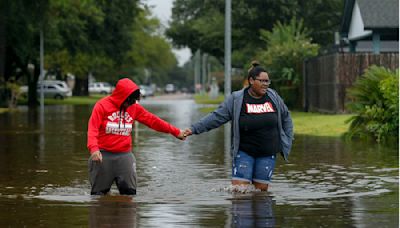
[185,62,293,191]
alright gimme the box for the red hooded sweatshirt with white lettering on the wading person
[87,78,180,153]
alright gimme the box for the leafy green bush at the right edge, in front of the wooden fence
[346,66,399,143]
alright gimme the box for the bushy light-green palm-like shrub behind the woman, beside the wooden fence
[258,18,319,107]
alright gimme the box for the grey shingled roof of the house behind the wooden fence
[341,0,399,32]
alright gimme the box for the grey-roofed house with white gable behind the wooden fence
[340,0,399,54]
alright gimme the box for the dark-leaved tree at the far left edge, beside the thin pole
[0,0,49,107]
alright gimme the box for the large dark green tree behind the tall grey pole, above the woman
[166,0,343,67]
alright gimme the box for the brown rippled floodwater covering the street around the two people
[0,99,399,227]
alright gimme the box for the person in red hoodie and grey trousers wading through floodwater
[87,78,186,195]
